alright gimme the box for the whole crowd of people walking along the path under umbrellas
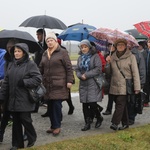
[0,29,150,150]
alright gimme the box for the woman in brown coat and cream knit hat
[39,32,73,136]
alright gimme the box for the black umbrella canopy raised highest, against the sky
[19,15,67,30]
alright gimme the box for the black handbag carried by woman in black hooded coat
[28,83,46,103]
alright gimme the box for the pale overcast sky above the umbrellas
[0,0,150,37]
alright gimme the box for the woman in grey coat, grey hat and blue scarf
[76,40,103,131]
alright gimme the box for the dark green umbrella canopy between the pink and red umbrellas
[125,29,147,40]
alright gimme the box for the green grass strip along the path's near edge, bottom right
[24,125,150,150]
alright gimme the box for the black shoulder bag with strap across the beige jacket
[116,61,134,94]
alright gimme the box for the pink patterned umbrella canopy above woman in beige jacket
[90,28,138,47]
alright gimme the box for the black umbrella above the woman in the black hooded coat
[0,30,42,53]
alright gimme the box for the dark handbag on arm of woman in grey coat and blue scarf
[94,73,109,90]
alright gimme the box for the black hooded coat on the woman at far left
[0,43,42,112]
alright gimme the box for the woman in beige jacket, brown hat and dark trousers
[106,39,141,130]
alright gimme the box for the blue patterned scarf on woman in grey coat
[80,53,92,71]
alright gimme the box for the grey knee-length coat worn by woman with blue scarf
[76,49,102,103]
